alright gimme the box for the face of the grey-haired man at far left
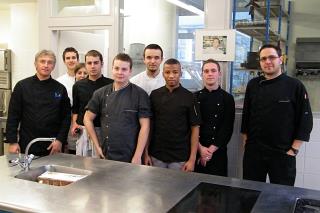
[34,55,55,79]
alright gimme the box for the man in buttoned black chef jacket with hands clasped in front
[195,59,235,176]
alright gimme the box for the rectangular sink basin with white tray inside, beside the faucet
[15,165,92,186]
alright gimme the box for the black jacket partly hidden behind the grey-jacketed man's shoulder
[72,75,113,127]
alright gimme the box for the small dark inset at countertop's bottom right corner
[294,198,320,213]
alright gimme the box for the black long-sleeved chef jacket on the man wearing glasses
[241,74,313,152]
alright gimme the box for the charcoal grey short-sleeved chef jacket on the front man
[87,83,151,162]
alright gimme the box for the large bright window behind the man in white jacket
[120,0,204,90]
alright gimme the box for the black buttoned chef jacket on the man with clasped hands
[195,87,235,148]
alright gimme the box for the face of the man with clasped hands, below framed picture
[202,63,221,86]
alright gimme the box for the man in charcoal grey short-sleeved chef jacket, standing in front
[84,53,151,164]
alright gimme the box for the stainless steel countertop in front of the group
[0,154,320,213]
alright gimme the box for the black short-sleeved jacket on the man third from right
[149,85,201,163]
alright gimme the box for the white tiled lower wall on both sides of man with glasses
[228,113,320,190]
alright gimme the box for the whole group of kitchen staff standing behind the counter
[7,44,312,185]
